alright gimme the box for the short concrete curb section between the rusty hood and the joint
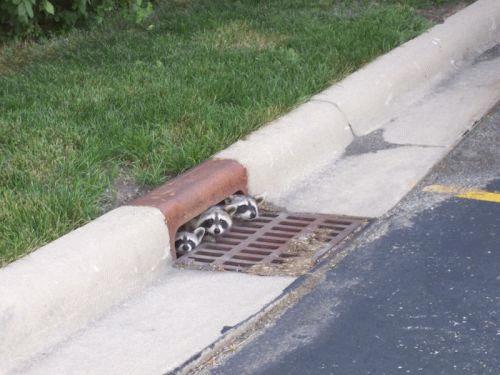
[215,101,353,199]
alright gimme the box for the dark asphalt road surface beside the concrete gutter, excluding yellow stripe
[204,106,500,374]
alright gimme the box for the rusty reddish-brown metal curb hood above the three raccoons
[130,159,247,259]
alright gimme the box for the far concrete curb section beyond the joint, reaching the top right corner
[313,0,500,135]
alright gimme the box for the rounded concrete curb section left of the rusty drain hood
[0,207,170,373]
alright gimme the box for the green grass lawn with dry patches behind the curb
[0,0,454,264]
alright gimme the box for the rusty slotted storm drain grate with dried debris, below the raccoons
[176,212,367,274]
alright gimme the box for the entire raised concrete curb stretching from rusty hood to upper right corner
[216,0,500,191]
